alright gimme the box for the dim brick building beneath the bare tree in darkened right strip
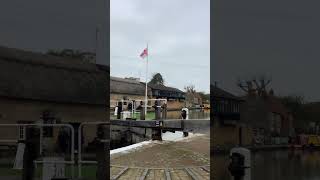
[240,90,293,144]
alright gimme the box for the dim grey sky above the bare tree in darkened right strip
[211,0,320,101]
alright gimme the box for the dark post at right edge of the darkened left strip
[95,125,110,180]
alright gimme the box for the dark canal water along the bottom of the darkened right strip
[213,150,320,180]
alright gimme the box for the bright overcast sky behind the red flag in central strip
[110,0,210,92]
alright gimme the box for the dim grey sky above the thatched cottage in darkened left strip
[0,0,102,52]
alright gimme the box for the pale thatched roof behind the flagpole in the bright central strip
[110,77,151,96]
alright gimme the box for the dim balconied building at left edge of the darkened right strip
[210,85,252,149]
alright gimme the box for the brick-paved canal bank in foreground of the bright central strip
[110,132,210,179]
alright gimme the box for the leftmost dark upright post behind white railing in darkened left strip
[22,127,40,180]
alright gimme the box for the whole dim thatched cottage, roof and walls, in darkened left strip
[0,47,109,150]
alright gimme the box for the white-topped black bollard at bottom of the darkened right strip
[228,147,251,180]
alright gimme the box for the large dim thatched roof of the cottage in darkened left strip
[0,46,109,105]
